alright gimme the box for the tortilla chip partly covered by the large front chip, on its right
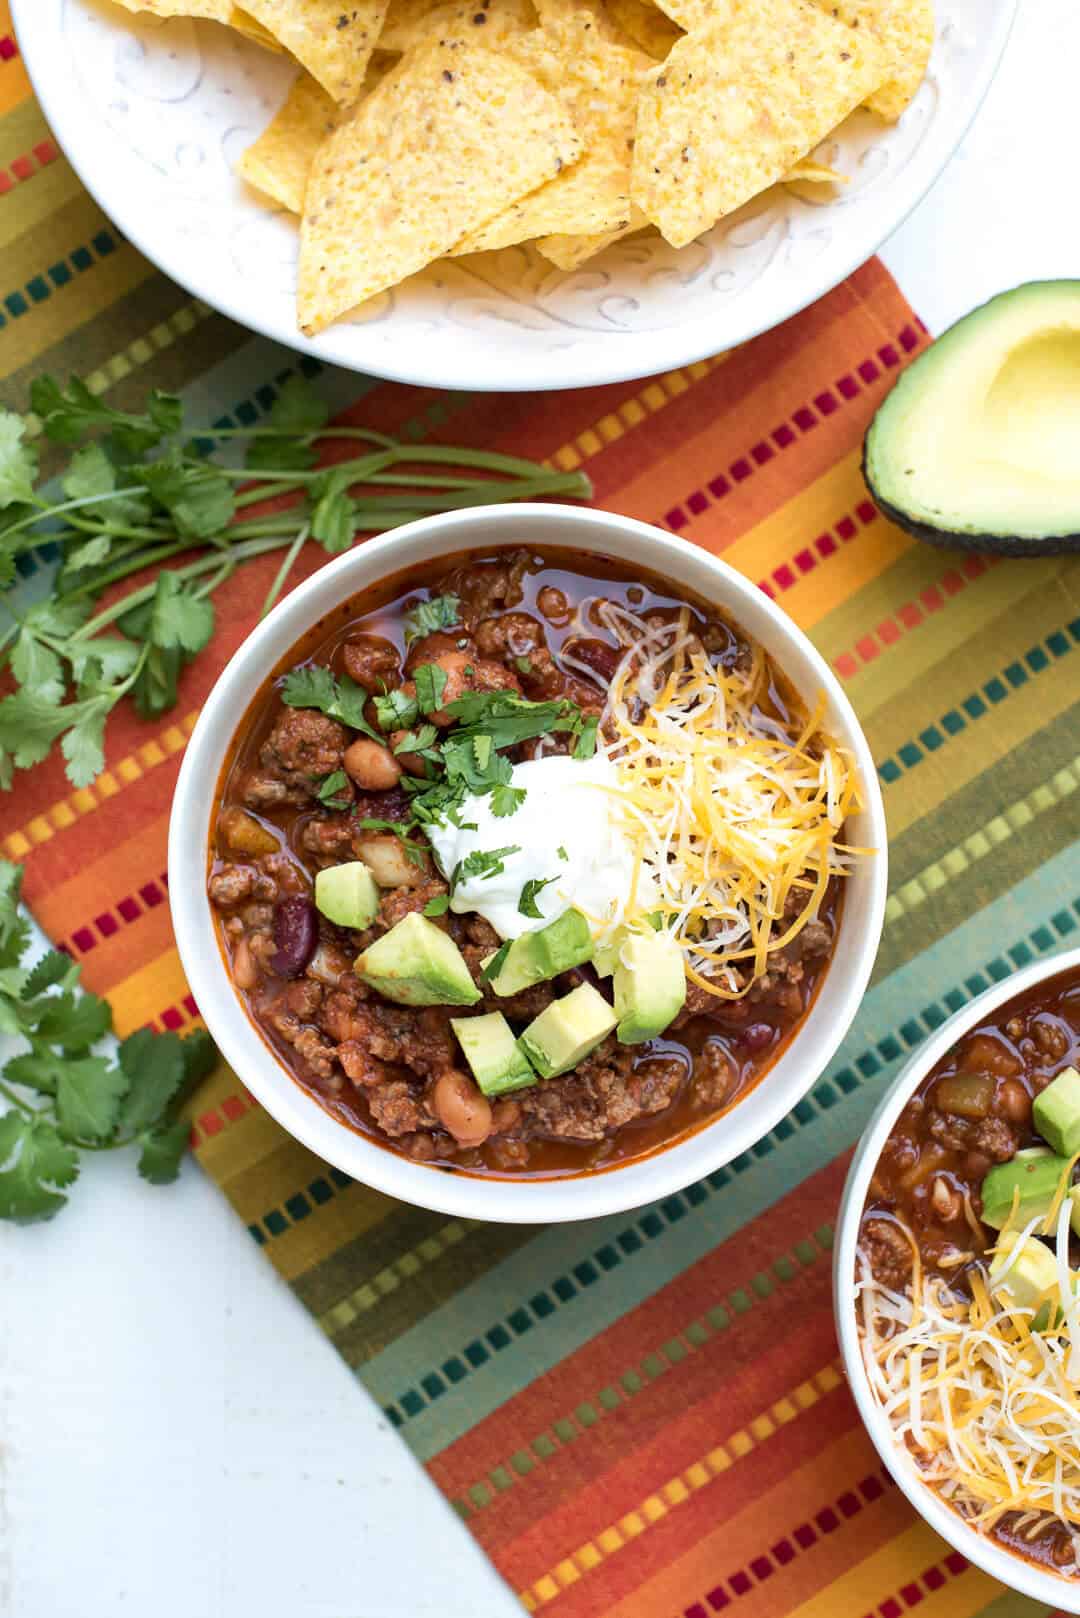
[453,11,651,257]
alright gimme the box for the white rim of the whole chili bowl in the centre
[168,503,887,1223]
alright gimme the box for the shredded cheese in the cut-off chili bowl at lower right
[855,1204,1080,1576]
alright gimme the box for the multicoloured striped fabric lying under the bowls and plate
[0,9,1080,1618]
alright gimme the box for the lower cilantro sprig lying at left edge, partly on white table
[0,861,217,1222]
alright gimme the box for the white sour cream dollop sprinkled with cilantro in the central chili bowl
[426,754,635,938]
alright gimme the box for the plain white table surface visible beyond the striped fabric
[0,0,1080,1618]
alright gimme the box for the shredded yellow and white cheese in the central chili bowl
[592,600,860,1000]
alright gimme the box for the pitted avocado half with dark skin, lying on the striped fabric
[863,282,1080,557]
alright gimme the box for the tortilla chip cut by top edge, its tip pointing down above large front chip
[243,0,387,107]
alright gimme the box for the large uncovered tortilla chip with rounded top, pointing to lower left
[298,40,581,335]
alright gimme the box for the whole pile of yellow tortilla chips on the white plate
[120,0,934,335]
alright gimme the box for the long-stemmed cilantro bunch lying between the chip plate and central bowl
[0,375,591,790]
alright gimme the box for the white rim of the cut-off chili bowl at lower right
[832,945,1080,1613]
